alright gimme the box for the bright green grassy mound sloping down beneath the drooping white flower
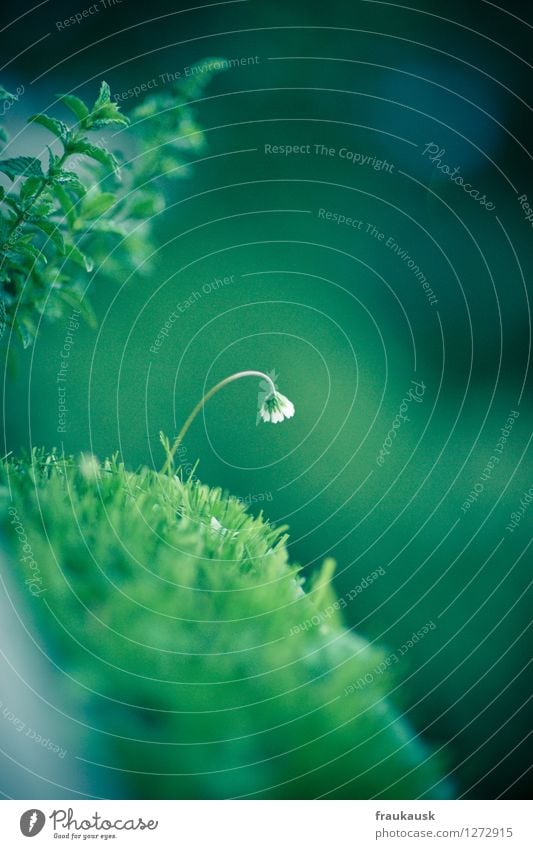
[1,452,449,799]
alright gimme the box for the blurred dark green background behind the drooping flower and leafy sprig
[2,0,533,798]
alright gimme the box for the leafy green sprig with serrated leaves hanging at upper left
[0,68,220,347]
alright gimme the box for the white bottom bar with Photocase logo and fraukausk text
[0,800,533,849]
